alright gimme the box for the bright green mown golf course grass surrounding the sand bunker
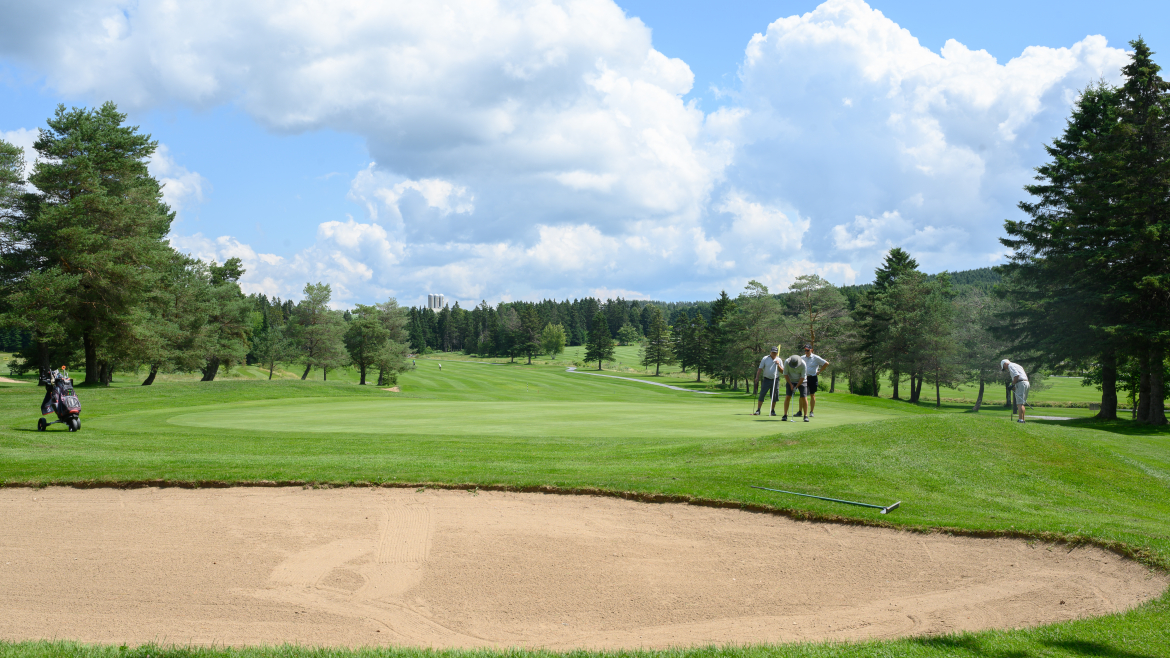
[0,357,1170,658]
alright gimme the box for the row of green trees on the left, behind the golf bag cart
[0,103,407,385]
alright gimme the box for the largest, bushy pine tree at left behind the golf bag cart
[2,103,174,384]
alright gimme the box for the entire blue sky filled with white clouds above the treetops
[0,0,1170,306]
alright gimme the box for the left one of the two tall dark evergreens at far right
[996,84,1121,419]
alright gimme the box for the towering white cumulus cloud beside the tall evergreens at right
[736,0,1127,269]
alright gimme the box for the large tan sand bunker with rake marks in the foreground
[0,488,1168,649]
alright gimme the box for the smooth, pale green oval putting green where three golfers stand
[167,393,890,438]
